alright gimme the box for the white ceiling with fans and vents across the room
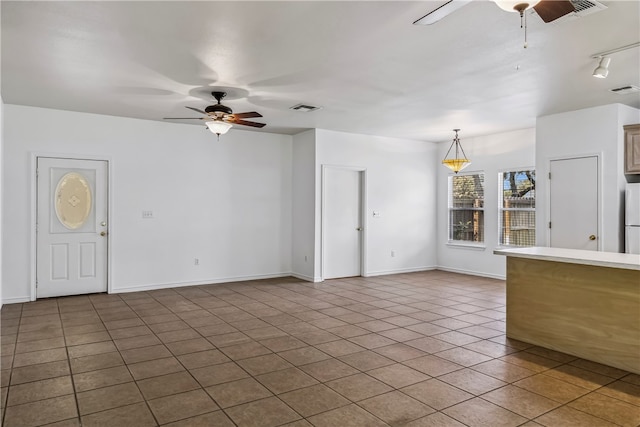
[1,0,640,141]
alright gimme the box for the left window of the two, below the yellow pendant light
[449,173,484,243]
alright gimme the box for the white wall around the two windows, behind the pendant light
[436,129,540,278]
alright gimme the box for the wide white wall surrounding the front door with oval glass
[2,105,292,302]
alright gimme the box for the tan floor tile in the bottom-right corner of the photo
[568,393,640,427]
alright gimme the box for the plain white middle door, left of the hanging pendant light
[323,168,363,279]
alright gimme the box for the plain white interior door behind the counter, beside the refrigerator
[549,156,599,251]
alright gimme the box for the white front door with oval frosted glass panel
[36,157,108,298]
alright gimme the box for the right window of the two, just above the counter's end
[498,170,536,246]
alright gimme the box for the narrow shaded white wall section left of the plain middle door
[291,129,321,282]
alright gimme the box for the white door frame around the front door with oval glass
[29,151,113,301]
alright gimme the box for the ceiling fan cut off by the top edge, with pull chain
[414,0,576,48]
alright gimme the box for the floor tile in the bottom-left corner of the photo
[4,395,78,427]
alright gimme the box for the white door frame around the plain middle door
[320,164,368,281]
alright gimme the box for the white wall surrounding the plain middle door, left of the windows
[315,129,437,276]
